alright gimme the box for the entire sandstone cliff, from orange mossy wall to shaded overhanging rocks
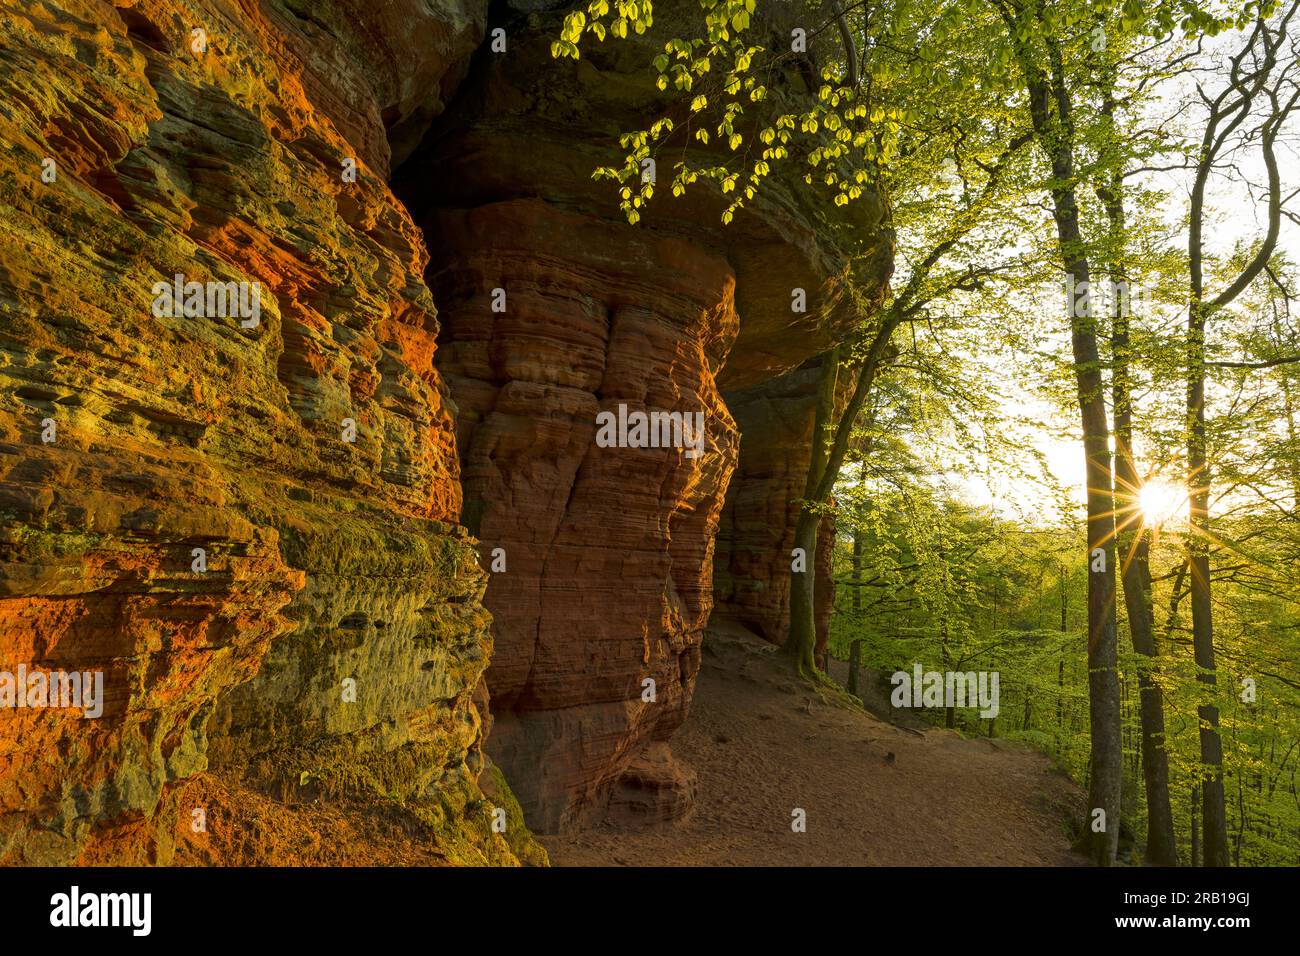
[0,0,889,864]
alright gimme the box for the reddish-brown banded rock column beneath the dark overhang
[423,200,738,829]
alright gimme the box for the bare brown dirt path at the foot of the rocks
[542,630,1084,866]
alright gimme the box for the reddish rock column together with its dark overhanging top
[395,3,889,831]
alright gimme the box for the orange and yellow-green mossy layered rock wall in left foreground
[0,0,538,862]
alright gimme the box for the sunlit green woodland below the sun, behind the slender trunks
[831,485,1300,866]
